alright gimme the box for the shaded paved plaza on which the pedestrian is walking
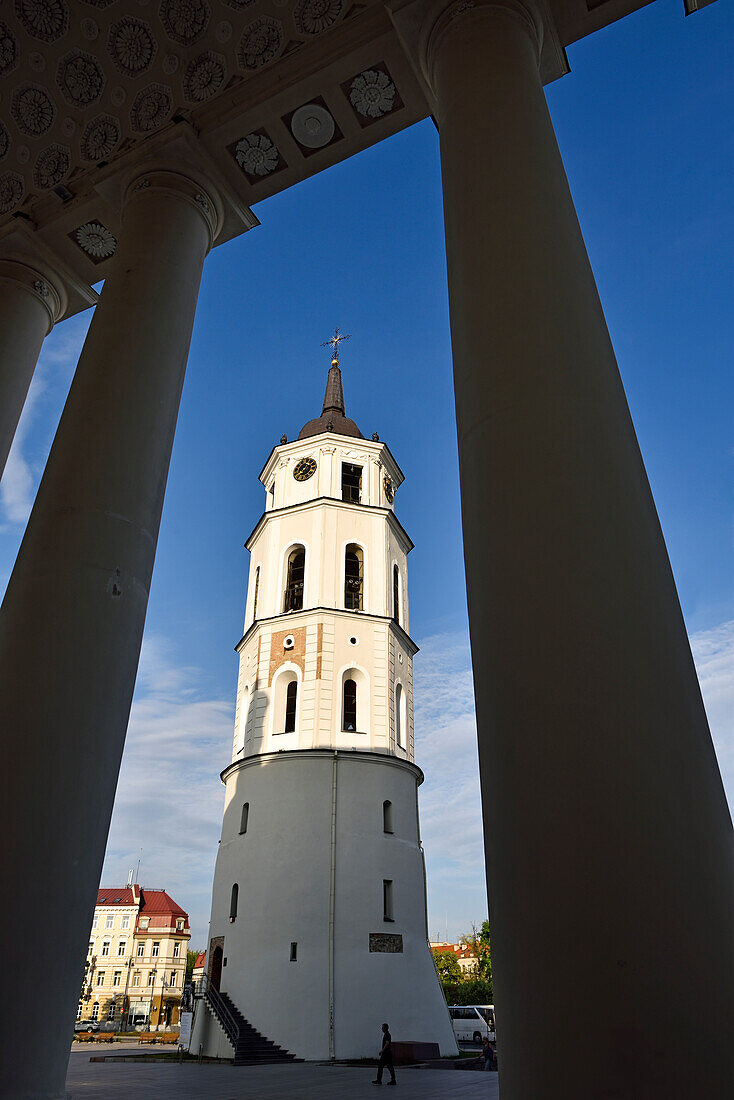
[66,1044,500,1100]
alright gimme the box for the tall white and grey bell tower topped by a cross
[195,330,456,1058]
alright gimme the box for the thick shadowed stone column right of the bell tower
[424,0,734,1100]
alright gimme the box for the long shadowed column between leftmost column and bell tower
[0,169,219,1100]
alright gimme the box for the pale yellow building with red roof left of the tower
[77,883,190,1031]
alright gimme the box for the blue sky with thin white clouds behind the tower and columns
[0,0,734,944]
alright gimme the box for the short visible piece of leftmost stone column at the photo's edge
[0,257,64,477]
